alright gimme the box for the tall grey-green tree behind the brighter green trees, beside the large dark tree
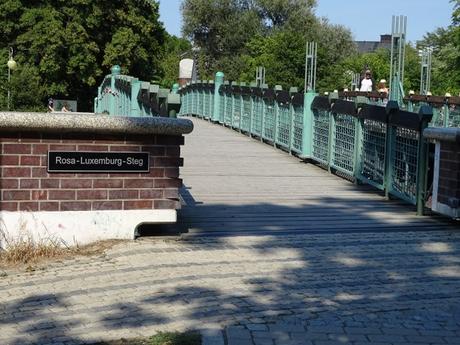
[182,0,322,79]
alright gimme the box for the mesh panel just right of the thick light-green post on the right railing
[313,109,329,164]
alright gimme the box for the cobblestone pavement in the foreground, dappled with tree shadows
[0,231,460,345]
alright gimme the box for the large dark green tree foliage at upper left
[0,0,165,110]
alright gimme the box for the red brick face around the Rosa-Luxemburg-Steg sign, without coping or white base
[0,132,184,211]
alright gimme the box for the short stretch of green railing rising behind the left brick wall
[94,66,180,117]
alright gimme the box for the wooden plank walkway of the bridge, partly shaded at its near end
[179,118,458,236]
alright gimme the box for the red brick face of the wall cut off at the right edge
[438,142,460,205]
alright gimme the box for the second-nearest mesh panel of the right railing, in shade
[360,119,387,189]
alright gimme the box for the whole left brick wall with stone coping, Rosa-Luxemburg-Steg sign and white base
[0,112,193,246]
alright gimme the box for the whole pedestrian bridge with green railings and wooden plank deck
[95,67,460,236]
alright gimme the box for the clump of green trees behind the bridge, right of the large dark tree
[182,0,355,87]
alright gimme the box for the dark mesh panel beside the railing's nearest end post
[391,128,419,204]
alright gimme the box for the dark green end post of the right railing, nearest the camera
[416,106,433,216]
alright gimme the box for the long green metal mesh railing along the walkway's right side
[180,71,433,214]
